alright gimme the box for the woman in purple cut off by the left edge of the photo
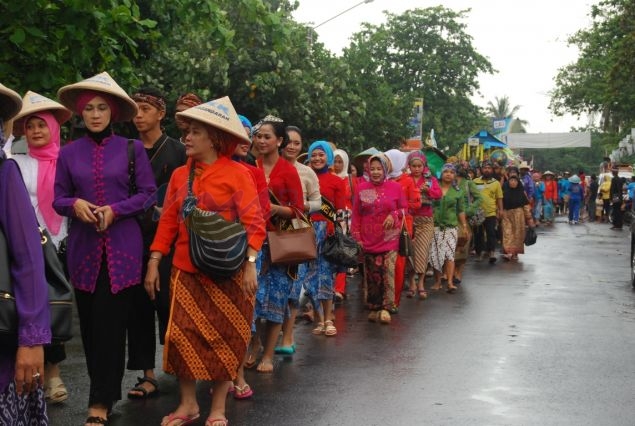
[0,84,51,426]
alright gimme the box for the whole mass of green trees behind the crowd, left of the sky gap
[0,0,493,153]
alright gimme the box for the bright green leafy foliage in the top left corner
[0,0,159,96]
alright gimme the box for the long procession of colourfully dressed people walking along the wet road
[0,73,635,426]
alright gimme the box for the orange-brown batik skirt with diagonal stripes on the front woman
[163,268,255,381]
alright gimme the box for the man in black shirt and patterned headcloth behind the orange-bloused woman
[127,88,186,399]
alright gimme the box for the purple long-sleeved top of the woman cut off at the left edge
[0,150,51,393]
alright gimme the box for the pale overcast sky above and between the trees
[294,0,598,133]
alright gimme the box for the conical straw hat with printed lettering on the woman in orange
[176,96,251,147]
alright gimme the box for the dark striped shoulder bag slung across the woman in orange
[183,162,247,280]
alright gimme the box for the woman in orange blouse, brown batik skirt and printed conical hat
[145,97,265,426]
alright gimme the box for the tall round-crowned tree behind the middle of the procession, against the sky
[344,6,493,148]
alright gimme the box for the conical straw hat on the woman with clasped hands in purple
[57,72,137,121]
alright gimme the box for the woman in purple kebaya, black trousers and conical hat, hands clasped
[53,73,156,426]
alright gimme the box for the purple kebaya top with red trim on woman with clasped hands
[53,135,156,294]
